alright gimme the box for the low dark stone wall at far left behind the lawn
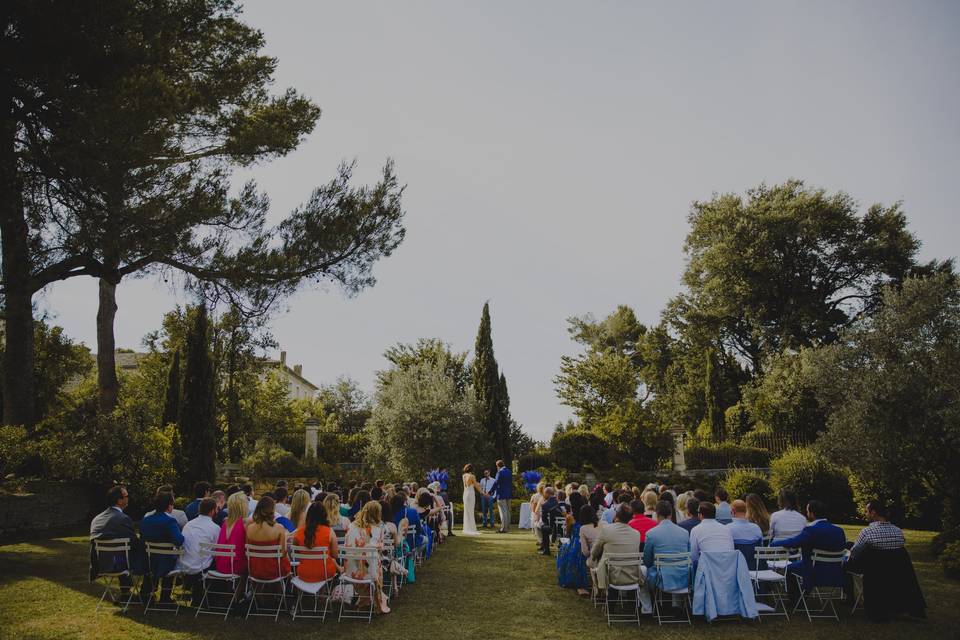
[0,480,103,535]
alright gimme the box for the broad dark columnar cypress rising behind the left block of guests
[175,303,217,487]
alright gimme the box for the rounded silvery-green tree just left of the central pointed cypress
[364,350,486,479]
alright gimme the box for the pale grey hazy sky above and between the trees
[38,0,960,439]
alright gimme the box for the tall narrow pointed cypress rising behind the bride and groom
[472,302,511,463]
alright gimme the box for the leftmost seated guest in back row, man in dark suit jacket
[90,485,145,600]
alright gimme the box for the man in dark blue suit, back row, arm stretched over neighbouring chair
[770,500,847,591]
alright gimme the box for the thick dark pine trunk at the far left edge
[0,108,36,427]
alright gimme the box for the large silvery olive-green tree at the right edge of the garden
[814,274,960,526]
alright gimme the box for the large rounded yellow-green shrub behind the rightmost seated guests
[770,447,856,520]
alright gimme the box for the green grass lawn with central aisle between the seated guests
[0,528,960,640]
